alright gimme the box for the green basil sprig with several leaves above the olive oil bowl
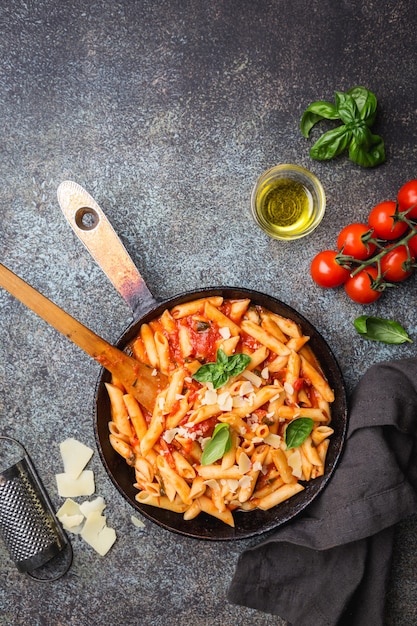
[300,87,385,167]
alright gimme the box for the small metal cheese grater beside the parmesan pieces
[0,435,72,581]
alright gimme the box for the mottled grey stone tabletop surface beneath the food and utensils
[0,0,417,626]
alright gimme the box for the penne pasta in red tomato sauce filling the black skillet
[106,296,334,527]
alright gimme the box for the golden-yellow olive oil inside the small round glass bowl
[258,178,313,236]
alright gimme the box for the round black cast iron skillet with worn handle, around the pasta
[58,181,347,540]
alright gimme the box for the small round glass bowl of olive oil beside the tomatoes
[251,164,326,240]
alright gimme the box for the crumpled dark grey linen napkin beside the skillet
[228,359,417,626]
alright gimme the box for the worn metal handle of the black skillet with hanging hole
[57,180,156,319]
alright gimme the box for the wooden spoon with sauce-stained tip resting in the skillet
[0,263,168,411]
